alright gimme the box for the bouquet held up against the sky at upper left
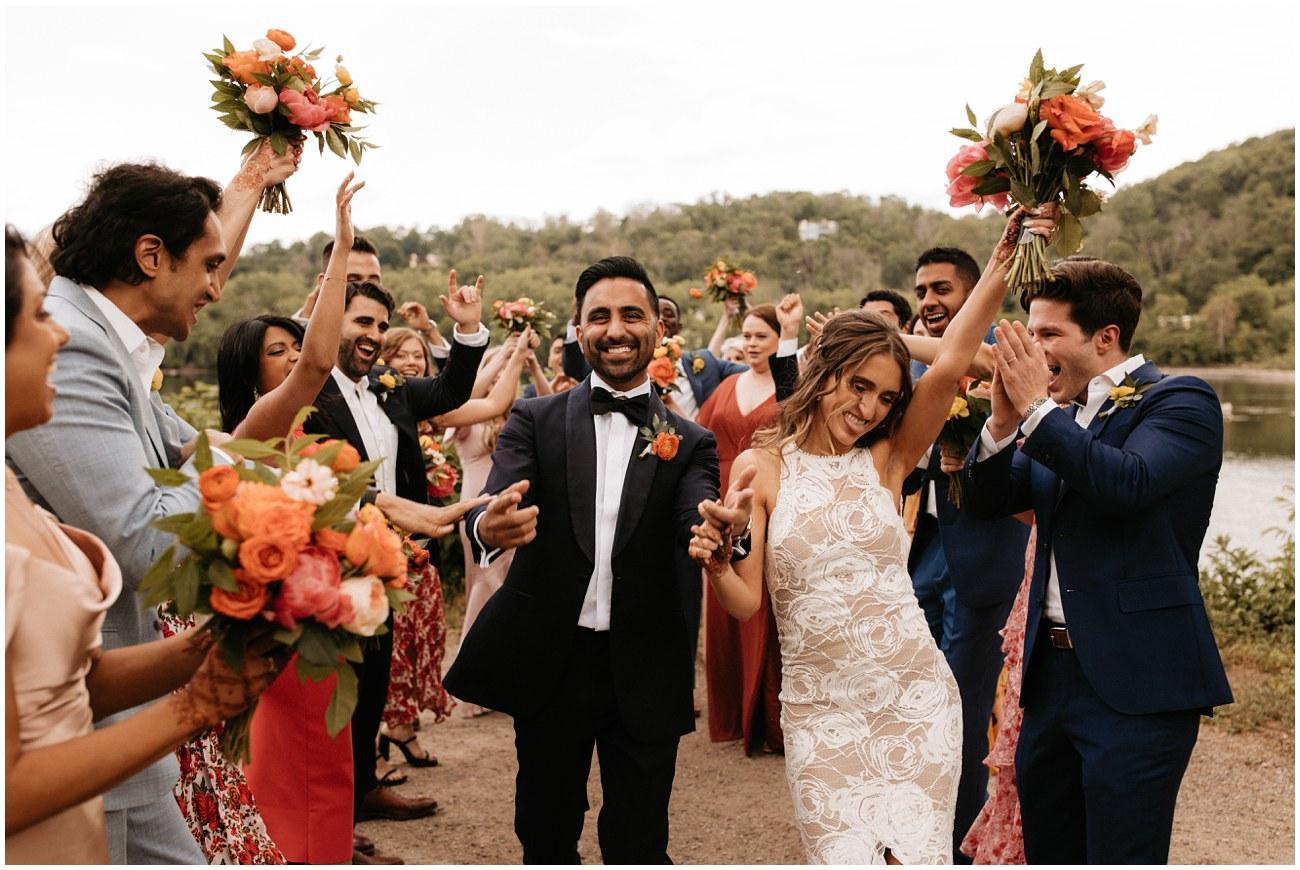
[203,30,378,215]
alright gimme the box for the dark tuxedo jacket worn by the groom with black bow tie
[445,380,718,740]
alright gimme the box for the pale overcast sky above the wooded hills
[4,1,1296,242]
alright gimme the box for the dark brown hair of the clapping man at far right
[1021,255,1141,354]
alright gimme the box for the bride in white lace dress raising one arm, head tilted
[690,208,1054,863]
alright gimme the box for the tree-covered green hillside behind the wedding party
[168,130,1295,367]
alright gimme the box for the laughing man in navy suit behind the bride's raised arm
[905,247,1030,863]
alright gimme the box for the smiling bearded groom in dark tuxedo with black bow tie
[445,257,718,863]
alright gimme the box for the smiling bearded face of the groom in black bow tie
[577,278,663,390]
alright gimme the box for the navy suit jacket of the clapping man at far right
[962,363,1232,714]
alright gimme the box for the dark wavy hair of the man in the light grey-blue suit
[49,163,221,287]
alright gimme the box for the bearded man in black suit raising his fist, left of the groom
[303,272,489,863]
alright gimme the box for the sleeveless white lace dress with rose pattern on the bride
[767,446,962,863]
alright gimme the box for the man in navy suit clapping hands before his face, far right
[962,257,1232,863]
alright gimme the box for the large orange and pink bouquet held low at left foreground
[140,407,411,761]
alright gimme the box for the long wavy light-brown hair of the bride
[754,308,911,455]
